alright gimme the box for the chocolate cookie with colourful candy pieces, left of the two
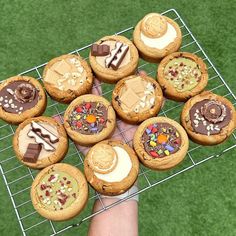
[64,94,116,146]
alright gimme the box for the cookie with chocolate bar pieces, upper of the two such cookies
[89,35,139,83]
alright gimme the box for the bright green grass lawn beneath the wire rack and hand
[0,0,236,236]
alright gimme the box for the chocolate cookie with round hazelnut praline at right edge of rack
[181,91,236,145]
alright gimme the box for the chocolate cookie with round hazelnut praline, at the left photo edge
[0,76,47,124]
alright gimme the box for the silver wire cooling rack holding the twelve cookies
[0,9,236,235]
